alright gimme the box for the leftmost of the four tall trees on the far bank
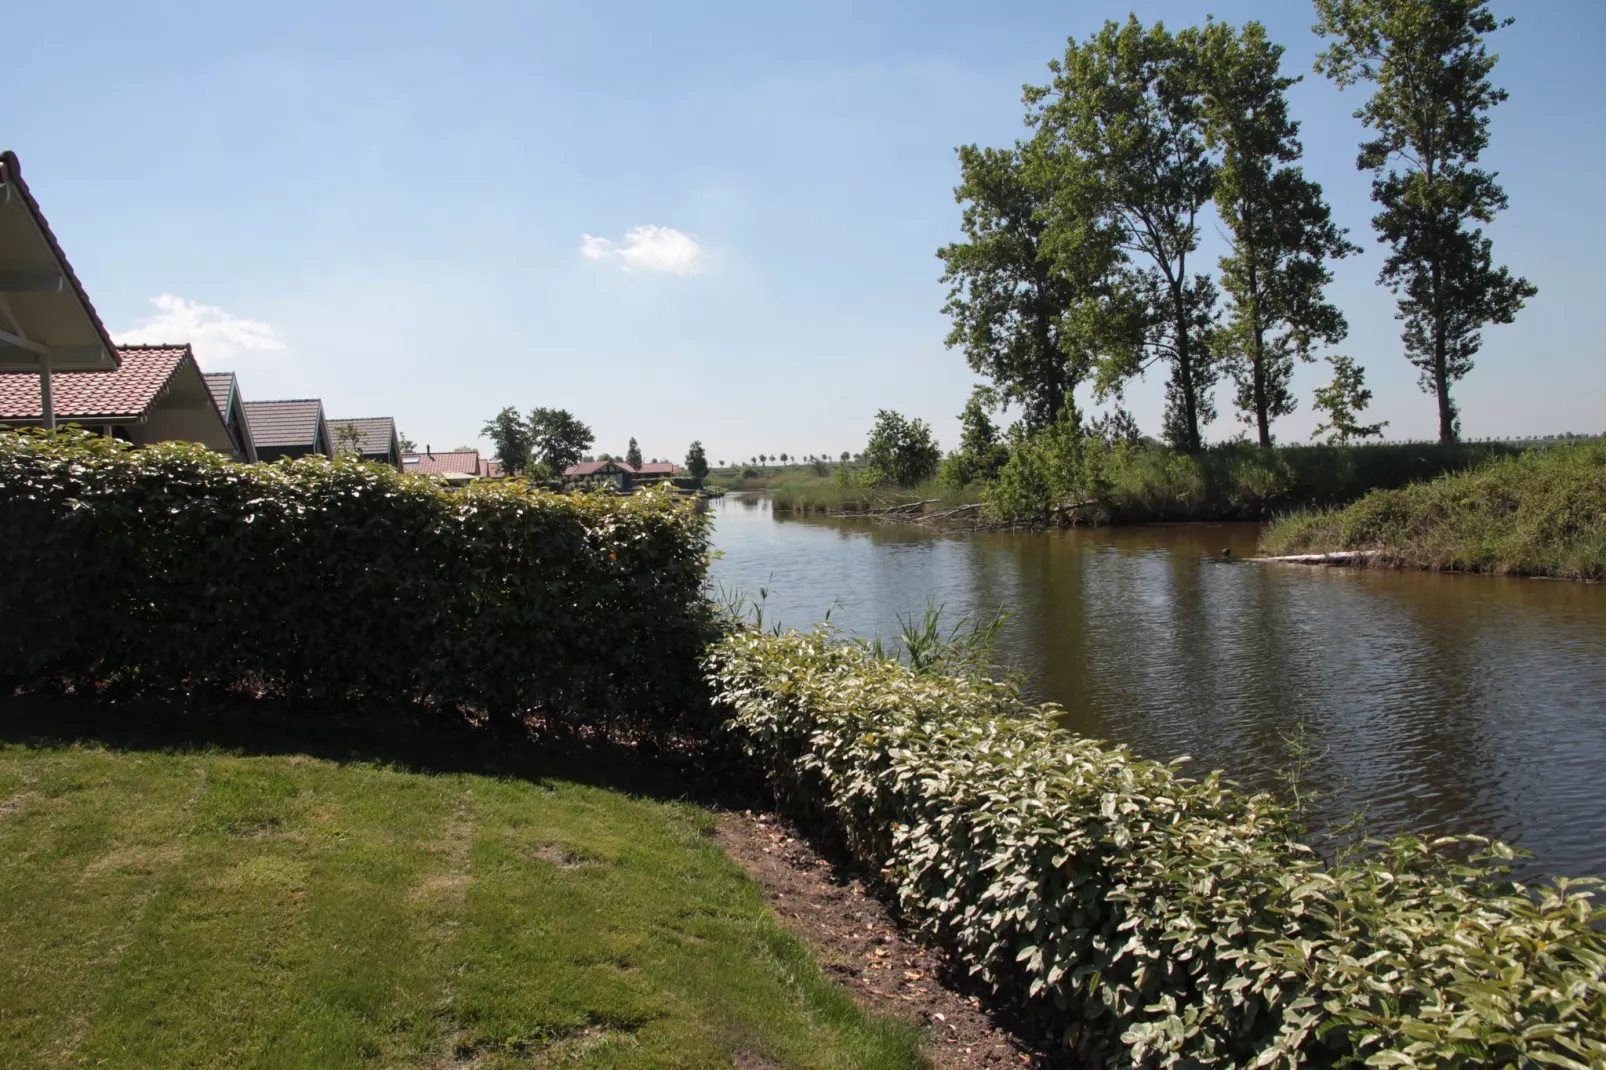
[936,145,1089,427]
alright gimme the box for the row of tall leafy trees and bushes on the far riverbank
[809,0,1537,514]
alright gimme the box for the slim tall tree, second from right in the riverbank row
[1177,22,1360,448]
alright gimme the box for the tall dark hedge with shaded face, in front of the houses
[0,431,710,729]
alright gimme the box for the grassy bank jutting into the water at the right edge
[1261,442,1606,580]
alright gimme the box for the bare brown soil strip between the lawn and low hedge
[716,811,1065,1070]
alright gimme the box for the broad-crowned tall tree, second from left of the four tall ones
[1026,16,1217,450]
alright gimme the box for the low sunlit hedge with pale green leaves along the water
[708,633,1606,1068]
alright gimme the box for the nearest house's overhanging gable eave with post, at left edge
[0,151,128,427]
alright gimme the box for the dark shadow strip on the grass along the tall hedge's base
[0,692,763,808]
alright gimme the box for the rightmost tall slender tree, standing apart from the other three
[1315,0,1539,442]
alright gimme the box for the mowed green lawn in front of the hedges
[0,704,925,1068]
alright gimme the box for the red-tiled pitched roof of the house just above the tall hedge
[0,345,194,423]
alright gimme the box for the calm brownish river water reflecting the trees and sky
[713,496,1606,876]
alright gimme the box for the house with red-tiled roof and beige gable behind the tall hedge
[0,345,238,456]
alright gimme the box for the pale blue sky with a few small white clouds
[0,0,1606,461]
